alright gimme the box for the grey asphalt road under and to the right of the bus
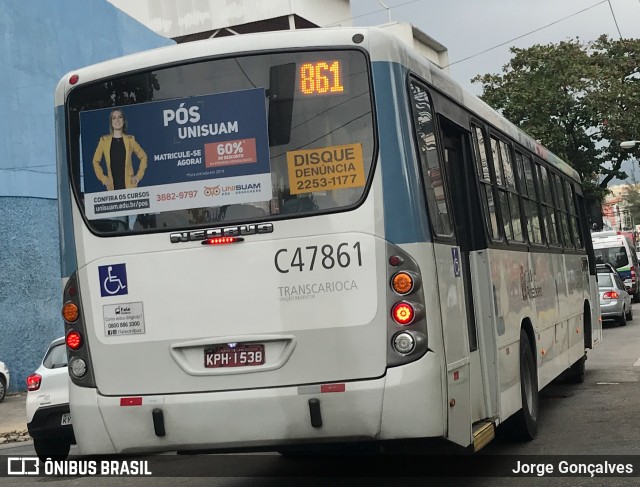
[0,304,640,487]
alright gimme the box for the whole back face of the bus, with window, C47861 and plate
[58,33,443,453]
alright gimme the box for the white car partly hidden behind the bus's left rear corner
[27,337,76,460]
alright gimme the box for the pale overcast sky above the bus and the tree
[351,0,640,186]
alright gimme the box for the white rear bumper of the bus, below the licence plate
[69,354,445,455]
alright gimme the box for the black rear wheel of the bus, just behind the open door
[511,329,539,441]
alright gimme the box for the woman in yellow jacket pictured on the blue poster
[93,108,147,191]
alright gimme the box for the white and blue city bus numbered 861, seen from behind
[56,28,601,454]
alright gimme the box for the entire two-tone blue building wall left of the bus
[0,0,174,391]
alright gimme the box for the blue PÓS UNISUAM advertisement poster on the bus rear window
[80,89,272,219]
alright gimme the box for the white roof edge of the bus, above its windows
[55,27,580,182]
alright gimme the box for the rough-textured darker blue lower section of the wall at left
[0,197,64,391]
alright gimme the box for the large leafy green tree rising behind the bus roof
[471,35,640,201]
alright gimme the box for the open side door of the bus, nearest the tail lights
[437,116,497,444]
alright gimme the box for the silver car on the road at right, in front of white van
[596,264,633,326]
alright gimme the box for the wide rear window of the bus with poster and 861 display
[67,50,374,235]
